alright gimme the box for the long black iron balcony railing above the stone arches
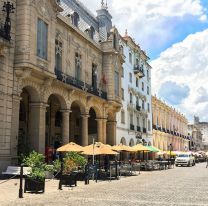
[55,70,107,99]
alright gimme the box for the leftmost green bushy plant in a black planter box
[23,151,59,193]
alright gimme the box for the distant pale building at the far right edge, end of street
[194,116,208,150]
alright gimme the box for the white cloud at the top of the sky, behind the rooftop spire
[77,0,207,54]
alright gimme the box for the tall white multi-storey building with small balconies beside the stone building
[116,32,152,146]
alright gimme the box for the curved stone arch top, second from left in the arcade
[43,87,70,109]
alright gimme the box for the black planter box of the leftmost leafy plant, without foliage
[24,178,45,193]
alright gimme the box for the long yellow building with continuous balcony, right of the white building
[152,96,189,151]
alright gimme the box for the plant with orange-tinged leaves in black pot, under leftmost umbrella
[62,152,87,186]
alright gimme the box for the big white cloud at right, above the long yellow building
[151,29,208,121]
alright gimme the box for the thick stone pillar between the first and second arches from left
[30,102,47,154]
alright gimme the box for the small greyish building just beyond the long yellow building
[188,124,203,151]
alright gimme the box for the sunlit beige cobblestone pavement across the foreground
[0,163,208,206]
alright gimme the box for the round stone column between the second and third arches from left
[61,110,70,145]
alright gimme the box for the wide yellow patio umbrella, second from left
[82,142,118,155]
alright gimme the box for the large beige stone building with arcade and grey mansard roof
[0,0,124,169]
